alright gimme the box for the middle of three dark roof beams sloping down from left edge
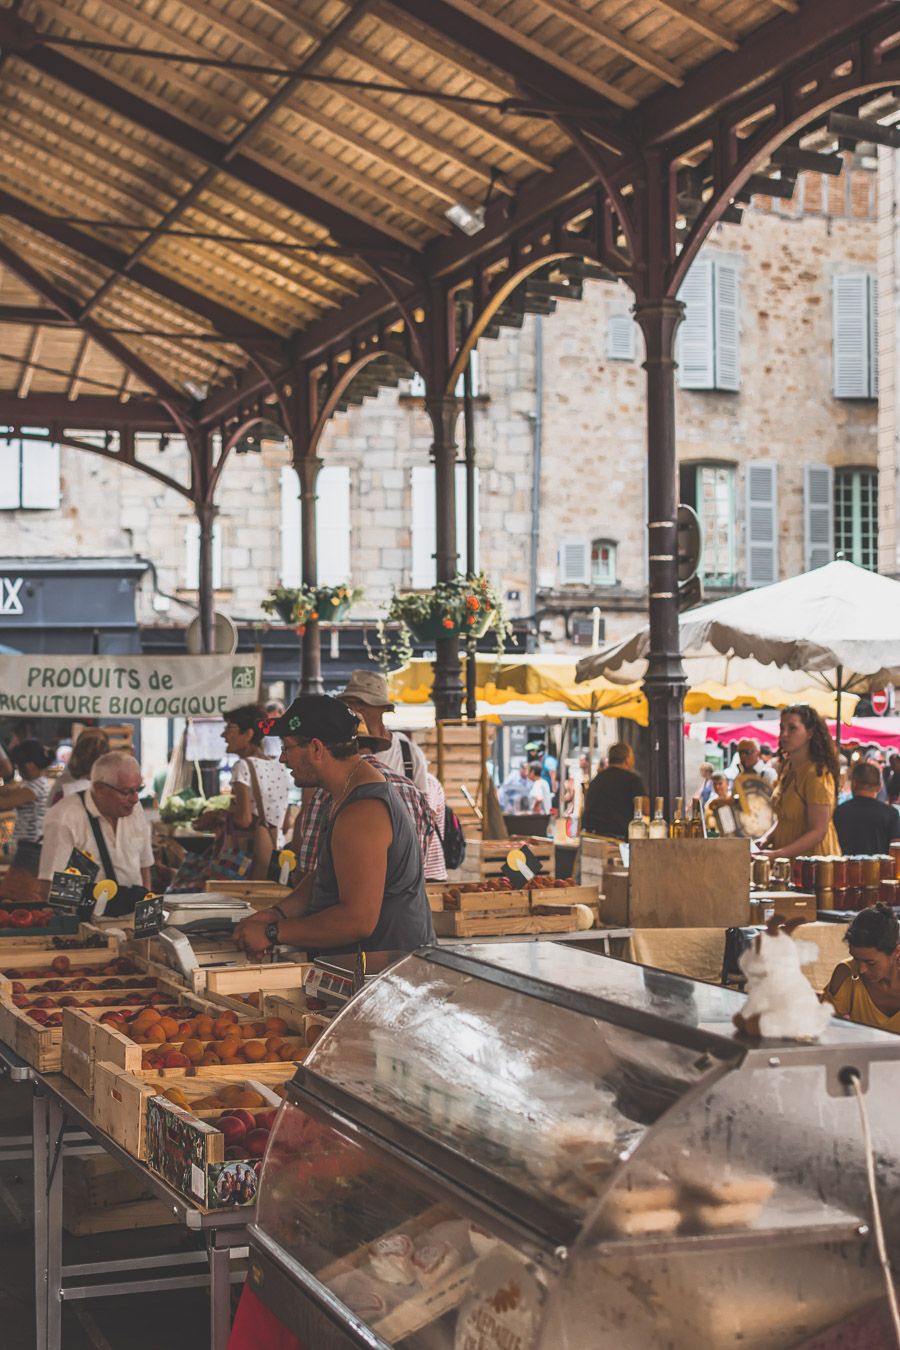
[0,189,283,344]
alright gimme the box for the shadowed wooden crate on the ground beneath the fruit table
[62,1154,175,1237]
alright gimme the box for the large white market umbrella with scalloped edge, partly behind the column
[576,562,900,750]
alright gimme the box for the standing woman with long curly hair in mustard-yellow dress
[760,703,841,857]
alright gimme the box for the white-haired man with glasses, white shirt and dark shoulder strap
[38,751,152,896]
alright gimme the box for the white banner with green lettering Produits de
[0,652,262,717]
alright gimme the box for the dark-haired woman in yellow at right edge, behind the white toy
[823,905,900,1034]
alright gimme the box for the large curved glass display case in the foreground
[250,944,900,1350]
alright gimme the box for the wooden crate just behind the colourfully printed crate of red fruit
[93,1061,290,1162]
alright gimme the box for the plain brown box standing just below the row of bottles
[602,838,750,929]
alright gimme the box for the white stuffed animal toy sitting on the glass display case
[733,914,831,1041]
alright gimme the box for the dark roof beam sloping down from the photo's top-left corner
[0,11,410,252]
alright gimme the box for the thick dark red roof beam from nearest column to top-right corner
[639,0,897,147]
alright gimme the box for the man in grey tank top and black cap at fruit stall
[235,694,434,956]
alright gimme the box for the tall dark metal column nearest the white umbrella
[634,298,687,811]
